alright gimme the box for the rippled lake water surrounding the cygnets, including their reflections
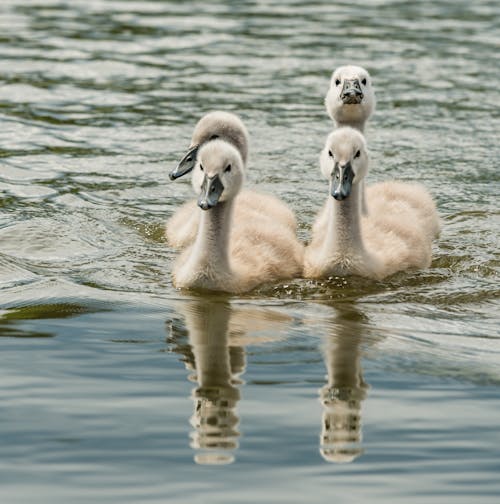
[0,0,500,503]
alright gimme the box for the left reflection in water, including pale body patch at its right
[169,298,291,464]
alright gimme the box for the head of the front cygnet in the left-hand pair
[192,139,244,210]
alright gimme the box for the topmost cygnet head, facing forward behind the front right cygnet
[325,65,375,130]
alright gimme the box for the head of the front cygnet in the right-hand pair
[320,126,369,201]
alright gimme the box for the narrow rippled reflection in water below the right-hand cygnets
[320,305,368,463]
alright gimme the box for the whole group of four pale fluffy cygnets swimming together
[166,65,440,293]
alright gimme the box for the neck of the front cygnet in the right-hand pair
[324,183,364,257]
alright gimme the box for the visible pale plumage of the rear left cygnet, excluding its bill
[165,111,297,248]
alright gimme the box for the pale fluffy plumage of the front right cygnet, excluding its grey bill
[304,127,439,279]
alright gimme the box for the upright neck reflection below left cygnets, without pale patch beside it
[172,298,241,464]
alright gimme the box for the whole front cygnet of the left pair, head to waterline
[174,140,303,293]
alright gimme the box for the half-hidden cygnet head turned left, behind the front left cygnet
[169,111,248,180]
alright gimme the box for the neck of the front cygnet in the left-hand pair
[192,200,233,274]
